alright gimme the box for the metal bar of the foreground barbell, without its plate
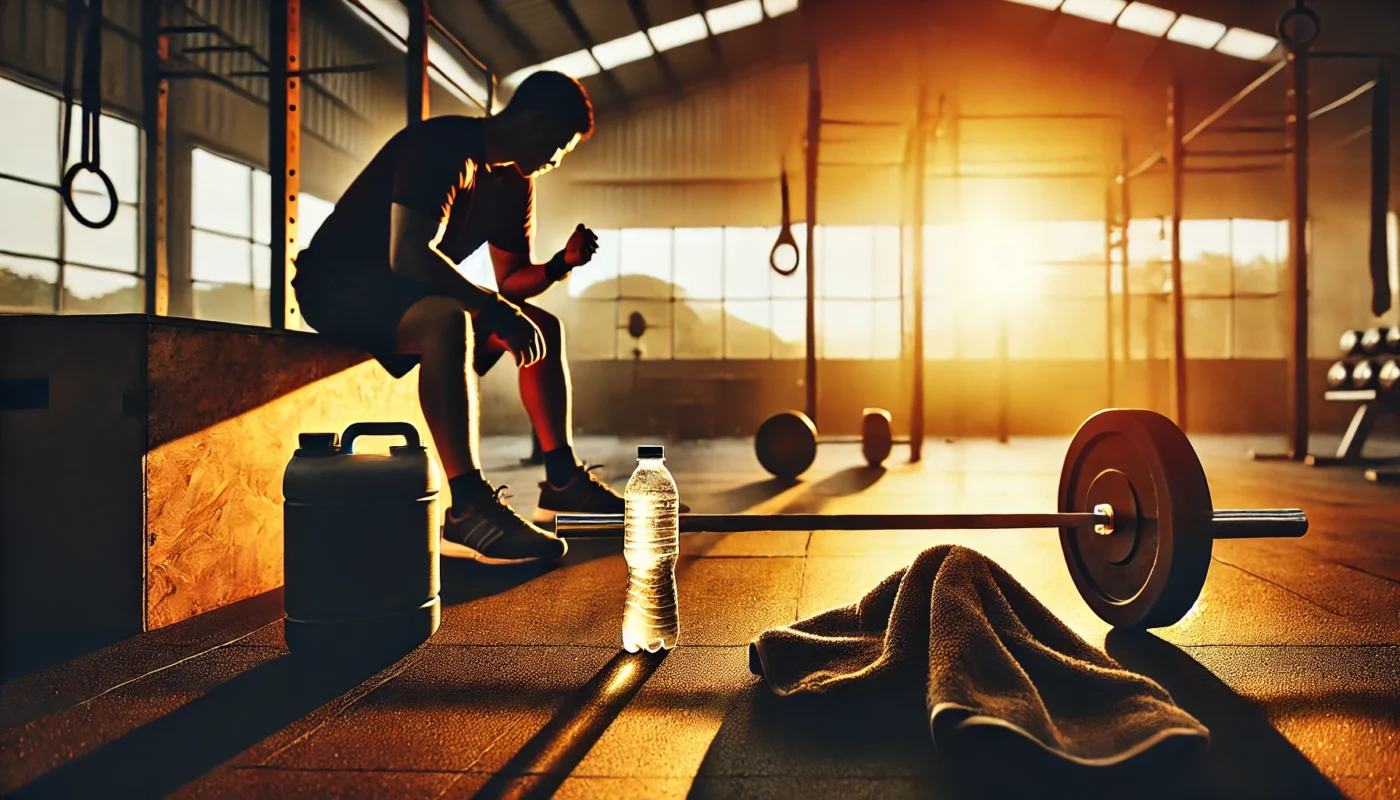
[554,509,1308,539]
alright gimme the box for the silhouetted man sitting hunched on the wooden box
[293,71,623,563]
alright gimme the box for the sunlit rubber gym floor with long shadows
[0,437,1400,799]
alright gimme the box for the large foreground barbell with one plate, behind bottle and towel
[554,409,1308,628]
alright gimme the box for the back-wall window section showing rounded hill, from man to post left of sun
[566,224,902,360]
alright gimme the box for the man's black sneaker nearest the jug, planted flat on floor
[442,486,568,565]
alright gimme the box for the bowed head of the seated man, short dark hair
[497,71,594,177]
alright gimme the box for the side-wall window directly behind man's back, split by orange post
[190,147,335,325]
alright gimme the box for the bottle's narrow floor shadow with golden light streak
[476,650,669,799]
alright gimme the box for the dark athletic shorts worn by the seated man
[291,259,503,378]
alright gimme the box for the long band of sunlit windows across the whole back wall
[551,220,1287,360]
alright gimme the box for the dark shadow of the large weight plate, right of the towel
[1105,629,1343,797]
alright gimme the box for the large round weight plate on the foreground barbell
[1060,409,1212,628]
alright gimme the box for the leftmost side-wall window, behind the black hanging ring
[0,78,146,314]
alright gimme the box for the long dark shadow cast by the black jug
[10,651,414,799]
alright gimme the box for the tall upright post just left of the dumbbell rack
[1284,45,1308,461]
